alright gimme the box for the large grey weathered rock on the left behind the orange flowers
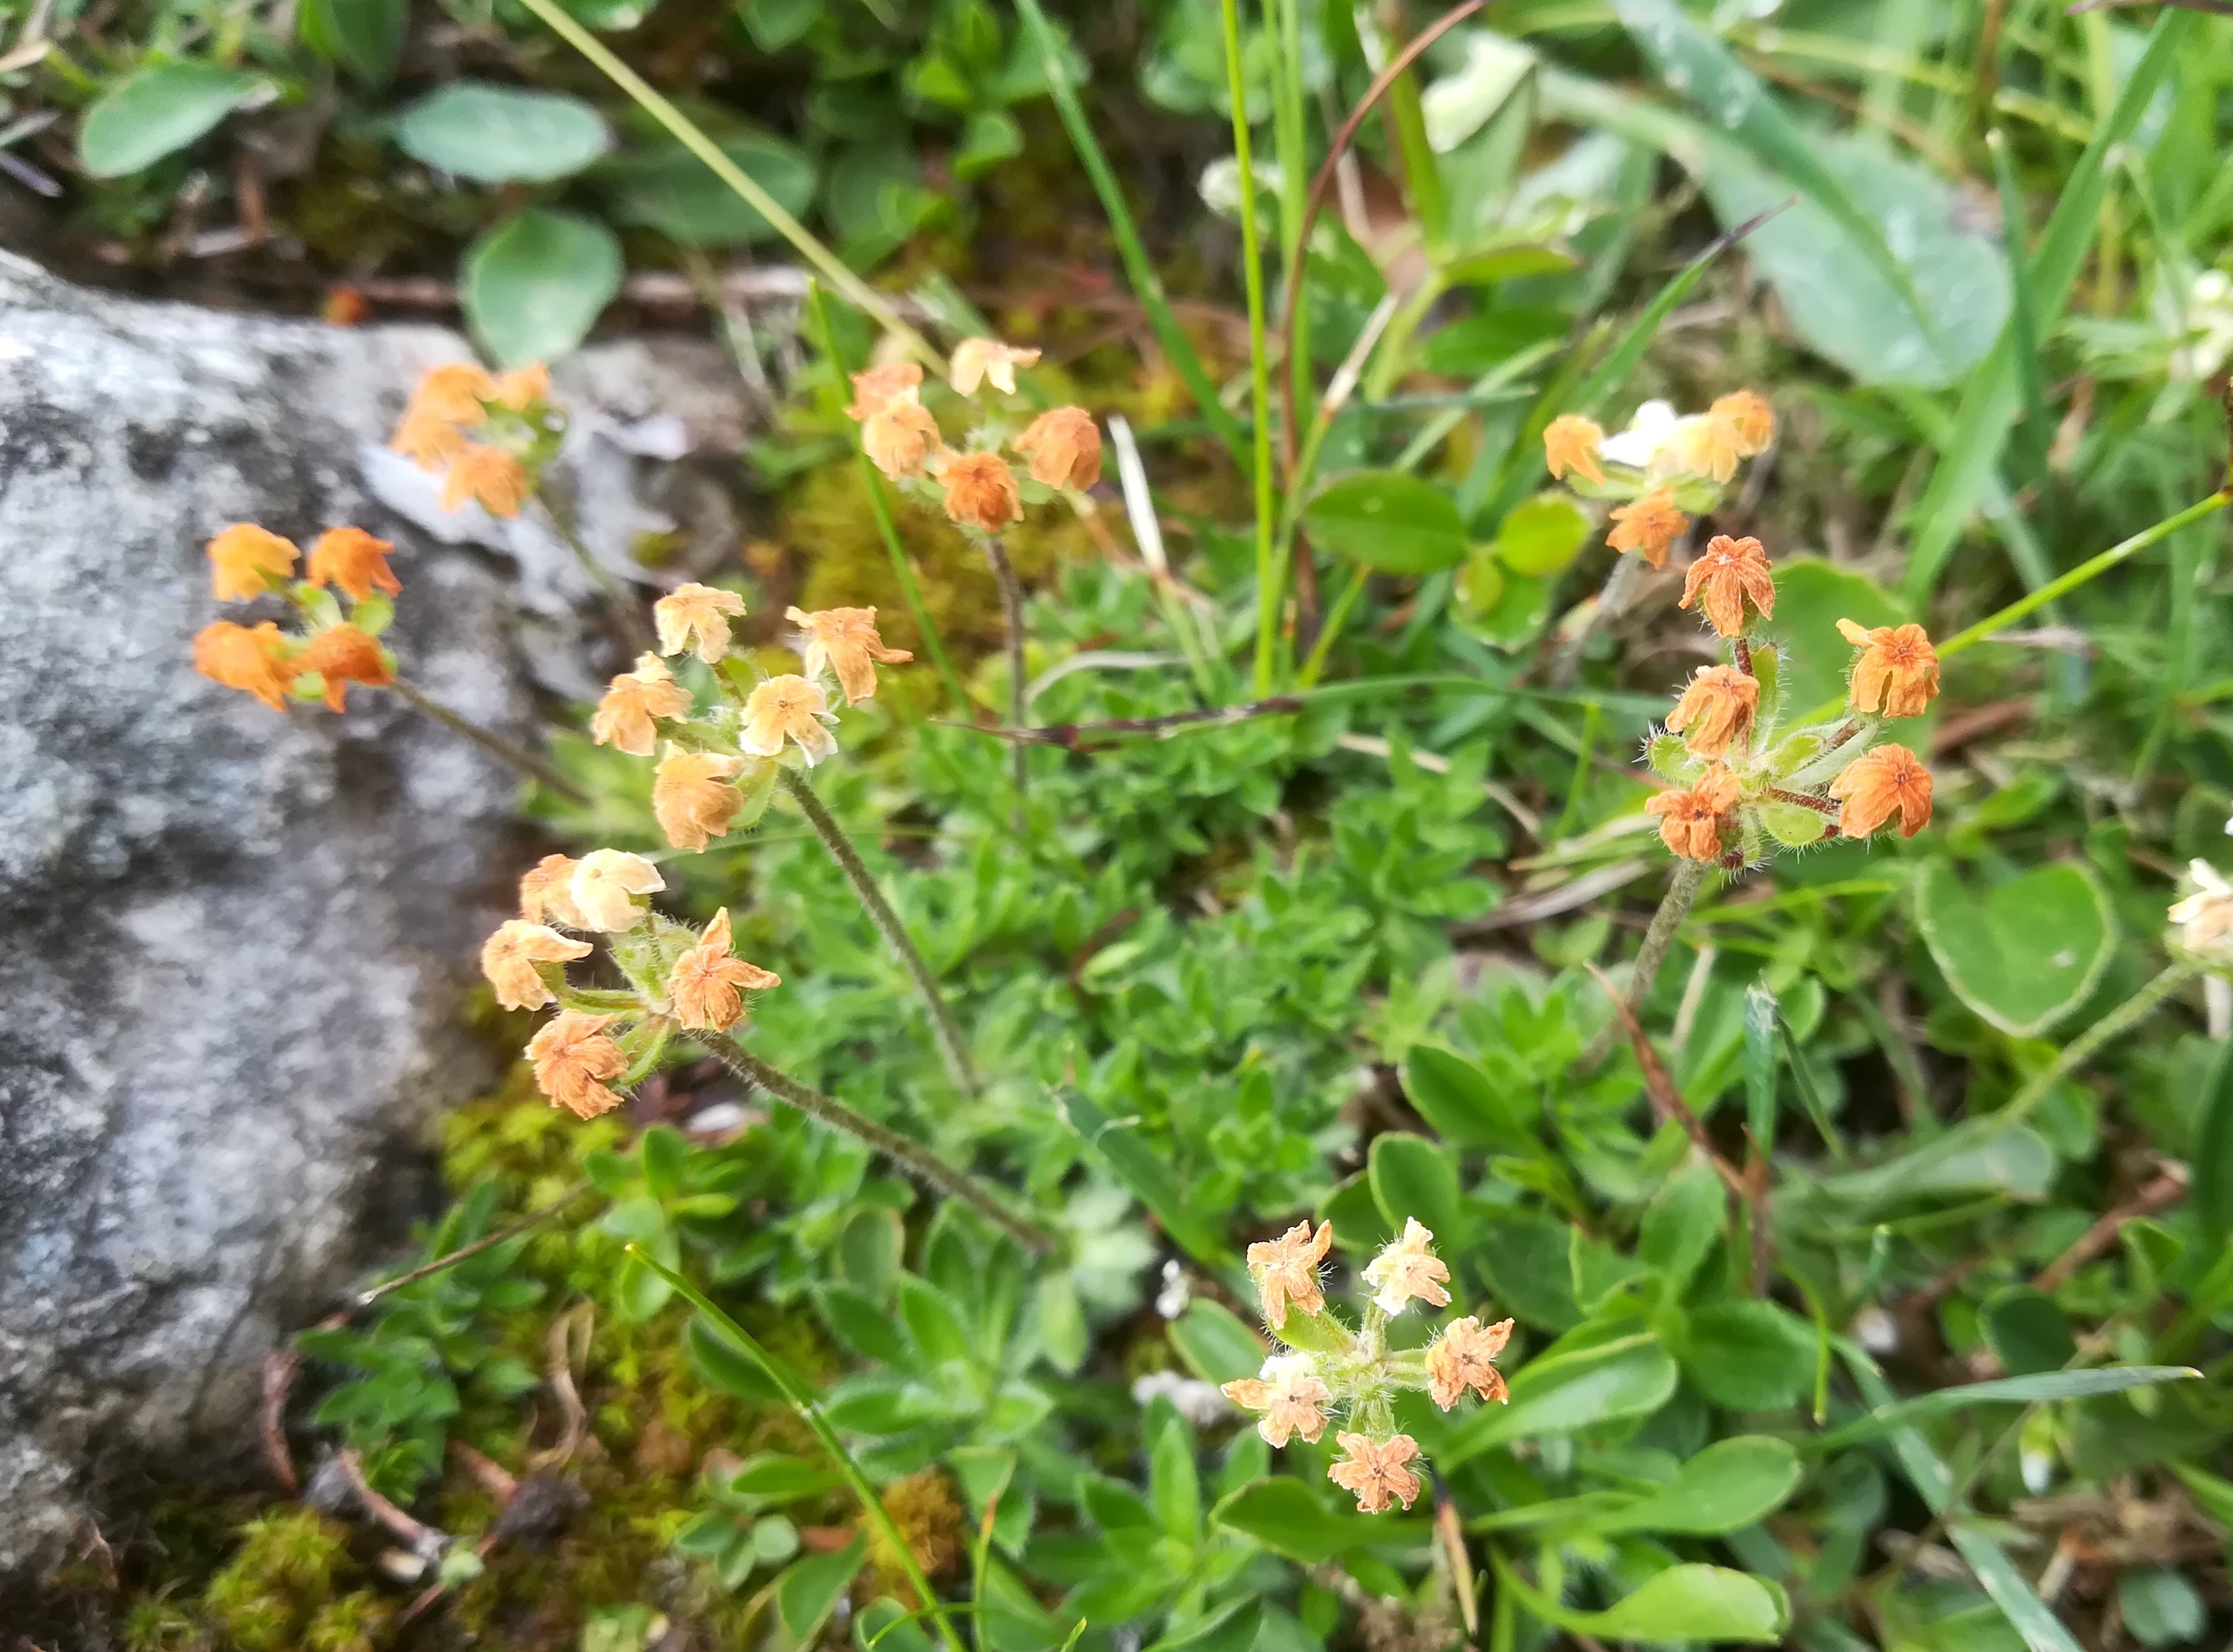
[0,254,746,1576]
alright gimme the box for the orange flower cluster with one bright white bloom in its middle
[1543,391,1775,567]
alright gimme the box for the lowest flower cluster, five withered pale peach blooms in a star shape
[1224,1216,1511,1513]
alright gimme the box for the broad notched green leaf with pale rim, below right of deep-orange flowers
[1914,859,2117,1038]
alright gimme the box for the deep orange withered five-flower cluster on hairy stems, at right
[1644,536,1938,866]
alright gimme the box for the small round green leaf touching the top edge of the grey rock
[458,207,621,366]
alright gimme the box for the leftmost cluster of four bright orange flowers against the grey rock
[194,522,402,712]
